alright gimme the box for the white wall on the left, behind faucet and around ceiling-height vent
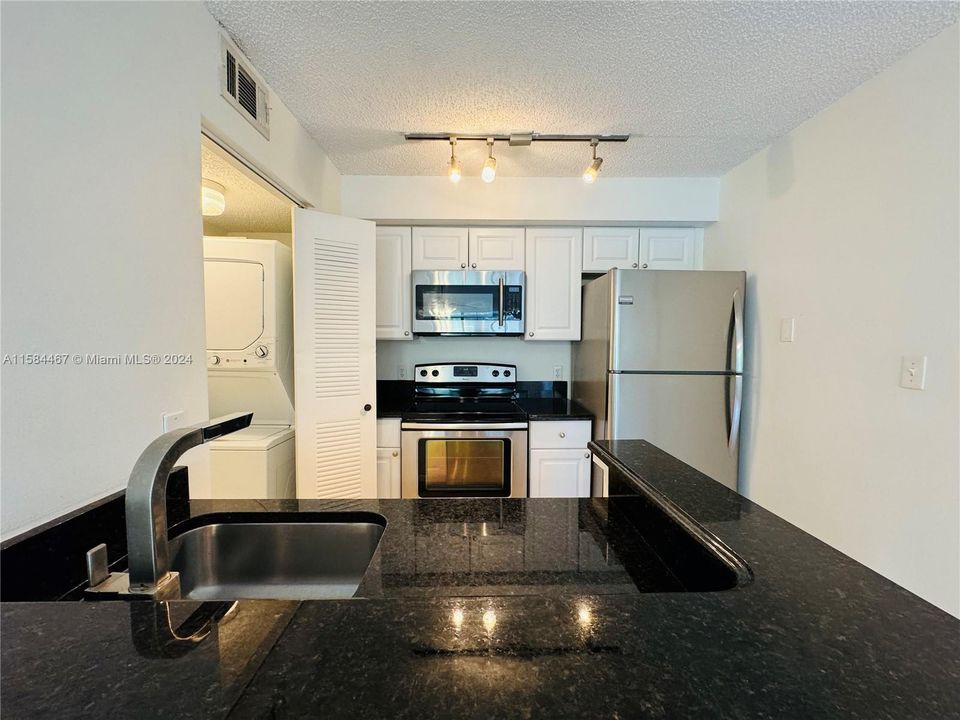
[0,3,339,538]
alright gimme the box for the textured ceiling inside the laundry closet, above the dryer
[200,142,293,235]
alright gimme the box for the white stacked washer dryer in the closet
[203,237,297,499]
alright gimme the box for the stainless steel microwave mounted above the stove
[413,270,524,335]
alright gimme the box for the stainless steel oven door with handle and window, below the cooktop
[400,422,527,498]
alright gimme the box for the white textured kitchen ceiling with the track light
[207,0,960,176]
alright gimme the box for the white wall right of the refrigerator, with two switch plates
[705,26,960,615]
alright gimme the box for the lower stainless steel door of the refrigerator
[607,373,743,490]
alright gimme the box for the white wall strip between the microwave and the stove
[377,337,570,382]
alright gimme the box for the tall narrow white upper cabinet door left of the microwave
[377,227,413,340]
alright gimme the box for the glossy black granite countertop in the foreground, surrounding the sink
[0,441,960,720]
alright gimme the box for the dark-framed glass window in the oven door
[418,438,510,497]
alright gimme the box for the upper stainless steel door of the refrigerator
[610,270,746,372]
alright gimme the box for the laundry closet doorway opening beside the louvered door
[200,135,297,499]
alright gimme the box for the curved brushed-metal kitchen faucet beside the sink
[126,412,253,599]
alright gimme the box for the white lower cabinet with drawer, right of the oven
[527,420,591,497]
